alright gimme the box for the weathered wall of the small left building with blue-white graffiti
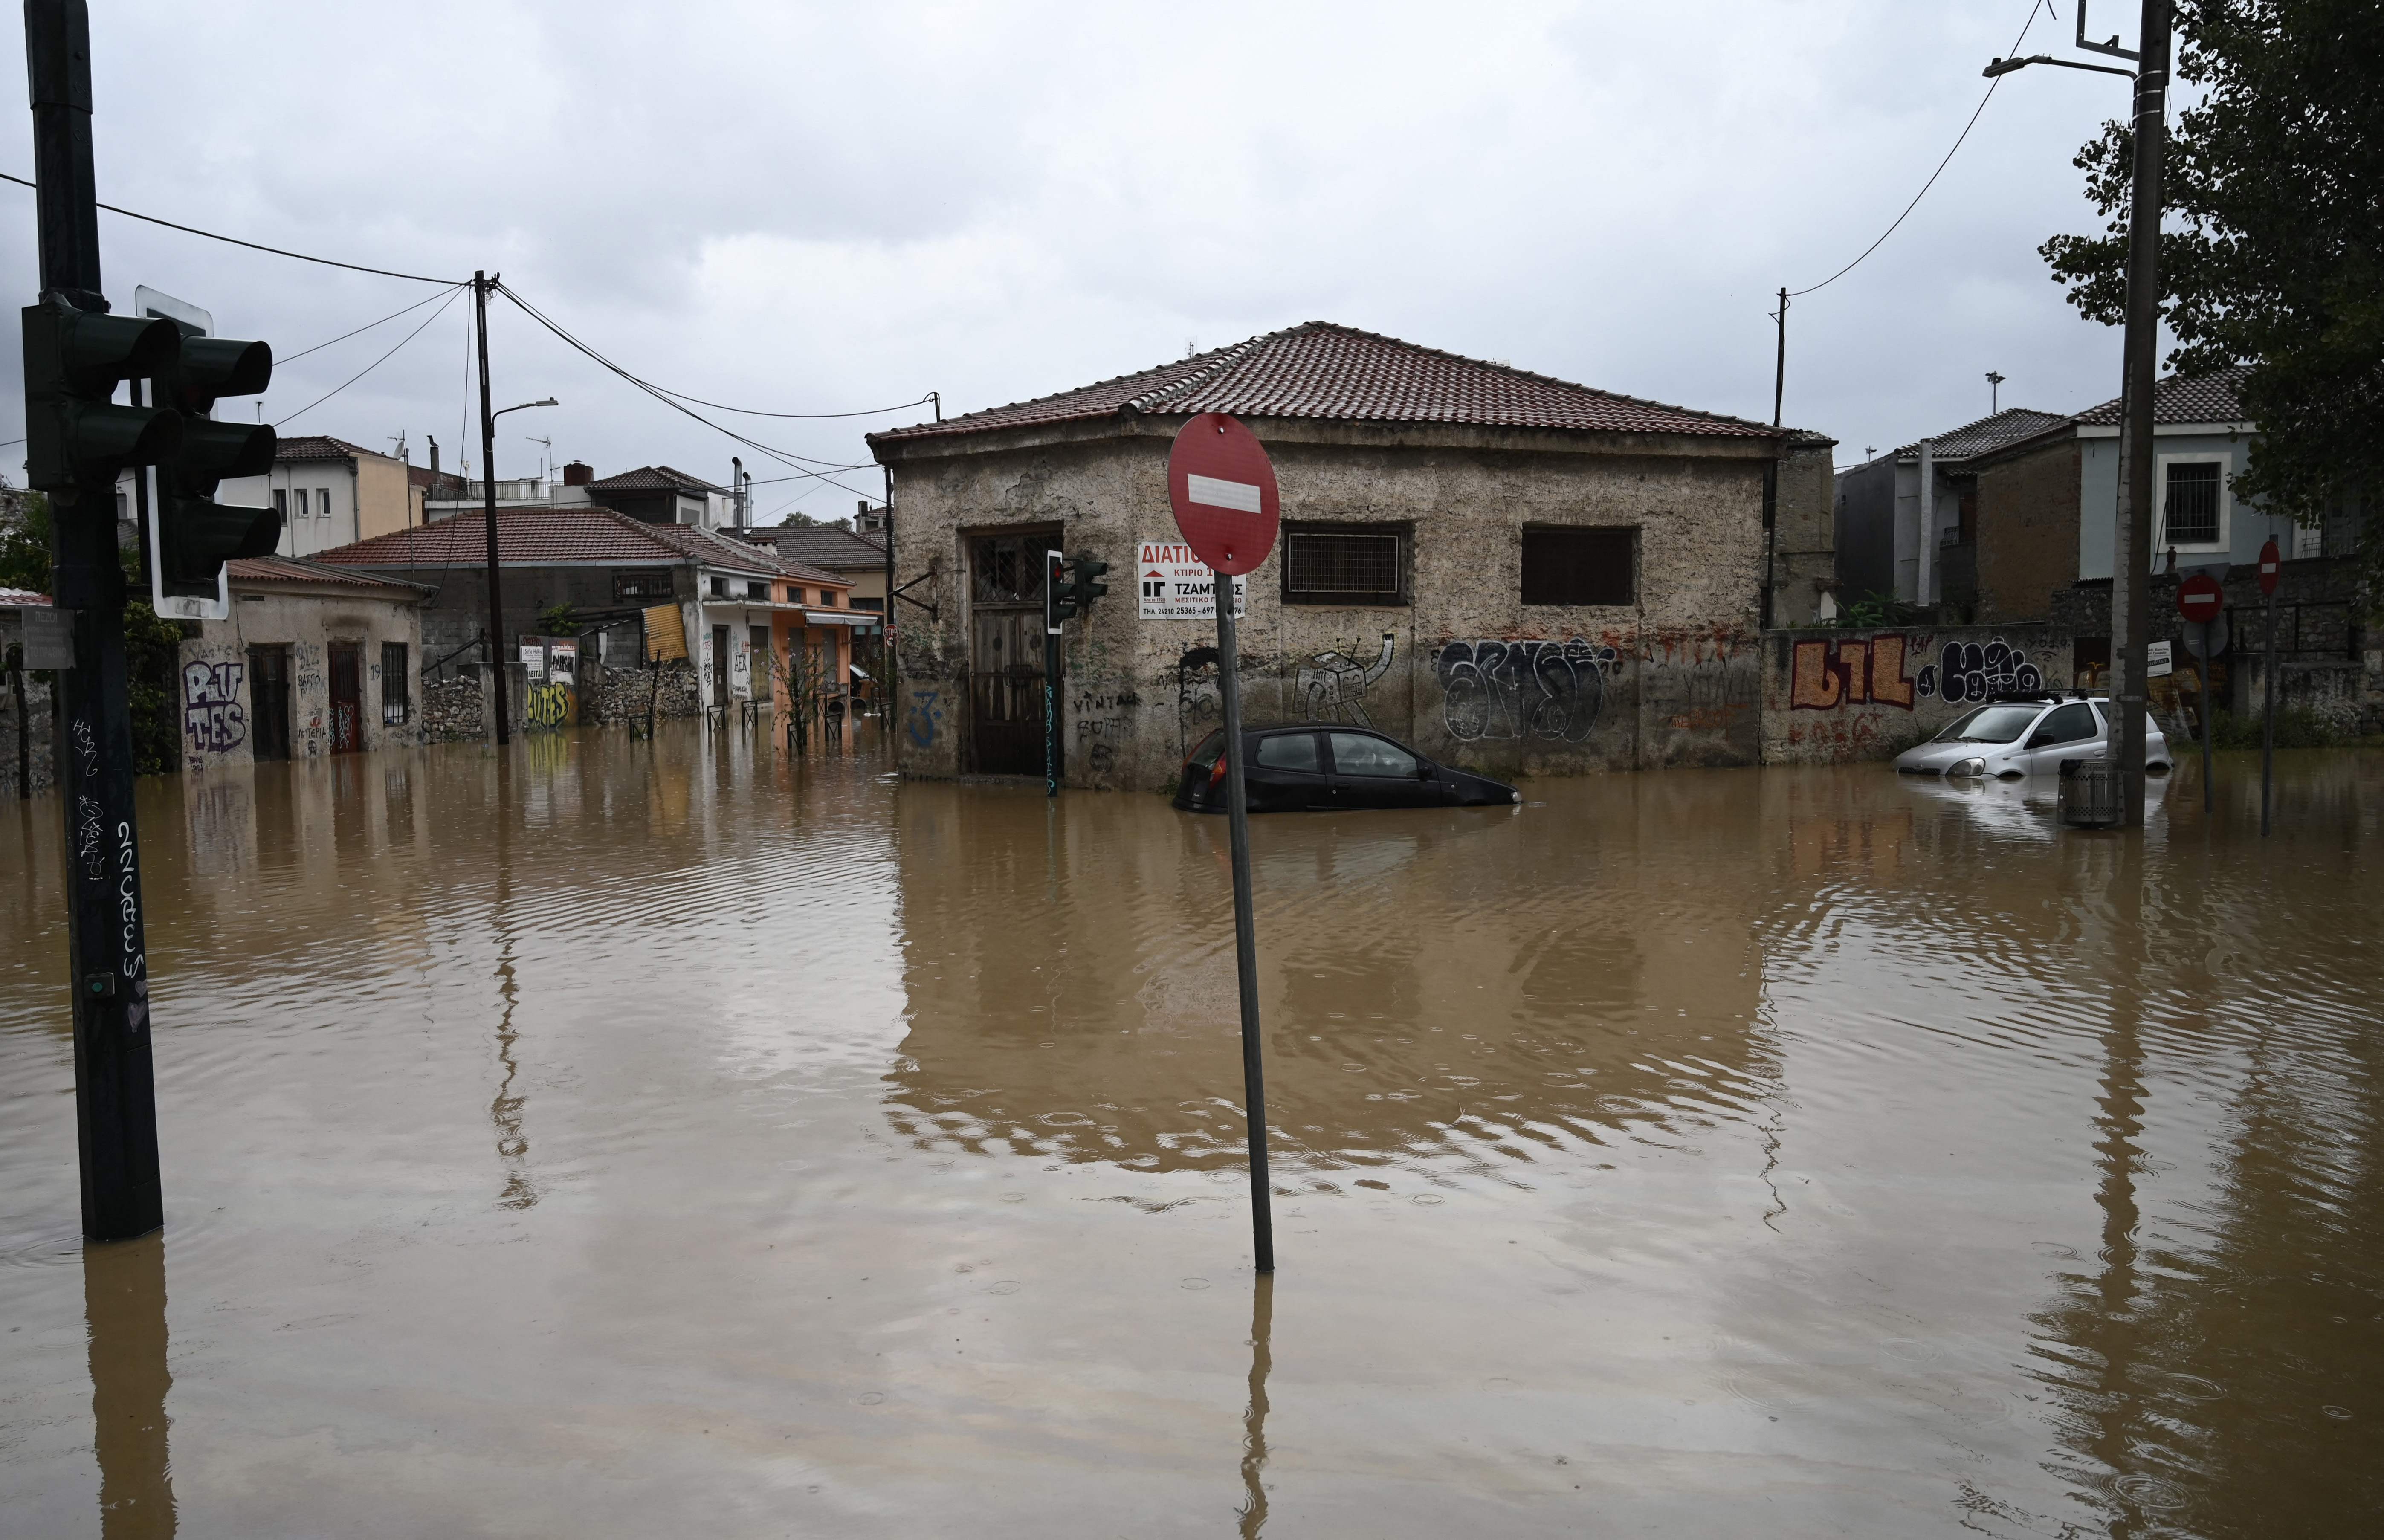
[179,589,422,773]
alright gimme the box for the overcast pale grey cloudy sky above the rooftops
[0,0,2164,522]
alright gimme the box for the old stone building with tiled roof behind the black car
[870,322,1831,789]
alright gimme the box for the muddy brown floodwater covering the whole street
[0,729,2384,1540]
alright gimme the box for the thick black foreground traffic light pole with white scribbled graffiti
[24,0,165,1239]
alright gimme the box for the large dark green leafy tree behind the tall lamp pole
[2038,0,2384,579]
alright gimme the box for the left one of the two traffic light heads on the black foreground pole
[24,298,184,491]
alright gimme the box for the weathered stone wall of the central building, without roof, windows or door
[896,420,1802,789]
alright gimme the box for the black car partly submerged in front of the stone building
[1175,722,1524,813]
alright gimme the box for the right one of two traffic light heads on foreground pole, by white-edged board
[150,322,281,598]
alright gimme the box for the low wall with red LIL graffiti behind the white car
[1764,627,2072,765]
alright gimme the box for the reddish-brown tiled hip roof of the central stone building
[868,322,1781,443]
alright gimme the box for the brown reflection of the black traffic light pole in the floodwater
[84,1233,174,1540]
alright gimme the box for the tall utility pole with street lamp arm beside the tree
[1984,0,2170,827]
